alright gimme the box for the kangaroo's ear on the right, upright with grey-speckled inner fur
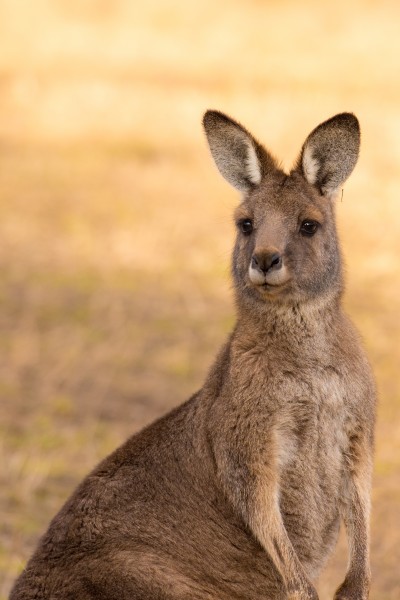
[296,113,360,198]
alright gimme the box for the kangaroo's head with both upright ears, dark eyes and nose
[203,111,360,304]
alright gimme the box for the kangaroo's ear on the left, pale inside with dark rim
[203,110,277,192]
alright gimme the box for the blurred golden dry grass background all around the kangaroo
[0,0,400,600]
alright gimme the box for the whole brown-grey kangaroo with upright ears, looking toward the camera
[10,111,375,600]
